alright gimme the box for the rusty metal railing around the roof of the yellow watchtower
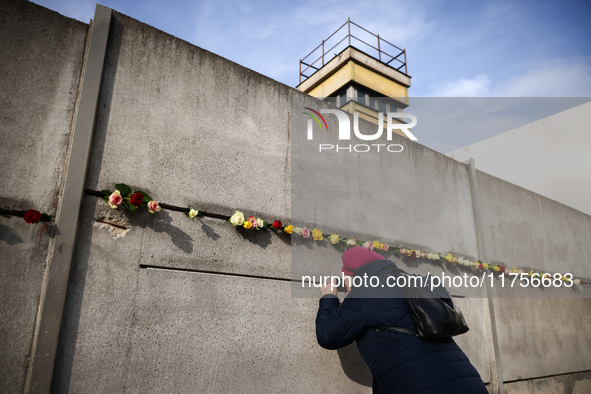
[300,18,408,83]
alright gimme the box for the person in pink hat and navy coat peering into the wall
[316,246,488,394]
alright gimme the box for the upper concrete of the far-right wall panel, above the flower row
[477,171,591,278]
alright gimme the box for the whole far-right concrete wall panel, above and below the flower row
[477,172,591,380]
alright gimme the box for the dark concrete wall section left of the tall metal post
[0,1,88,392]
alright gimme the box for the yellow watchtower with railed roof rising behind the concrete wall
[297,18,411,129]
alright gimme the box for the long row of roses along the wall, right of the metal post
[100,184,584,285]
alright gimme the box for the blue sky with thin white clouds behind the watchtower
[33,0,591,151]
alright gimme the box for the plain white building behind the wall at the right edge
[448,102,591,215]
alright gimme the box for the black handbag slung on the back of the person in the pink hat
[377,273,469,340]
